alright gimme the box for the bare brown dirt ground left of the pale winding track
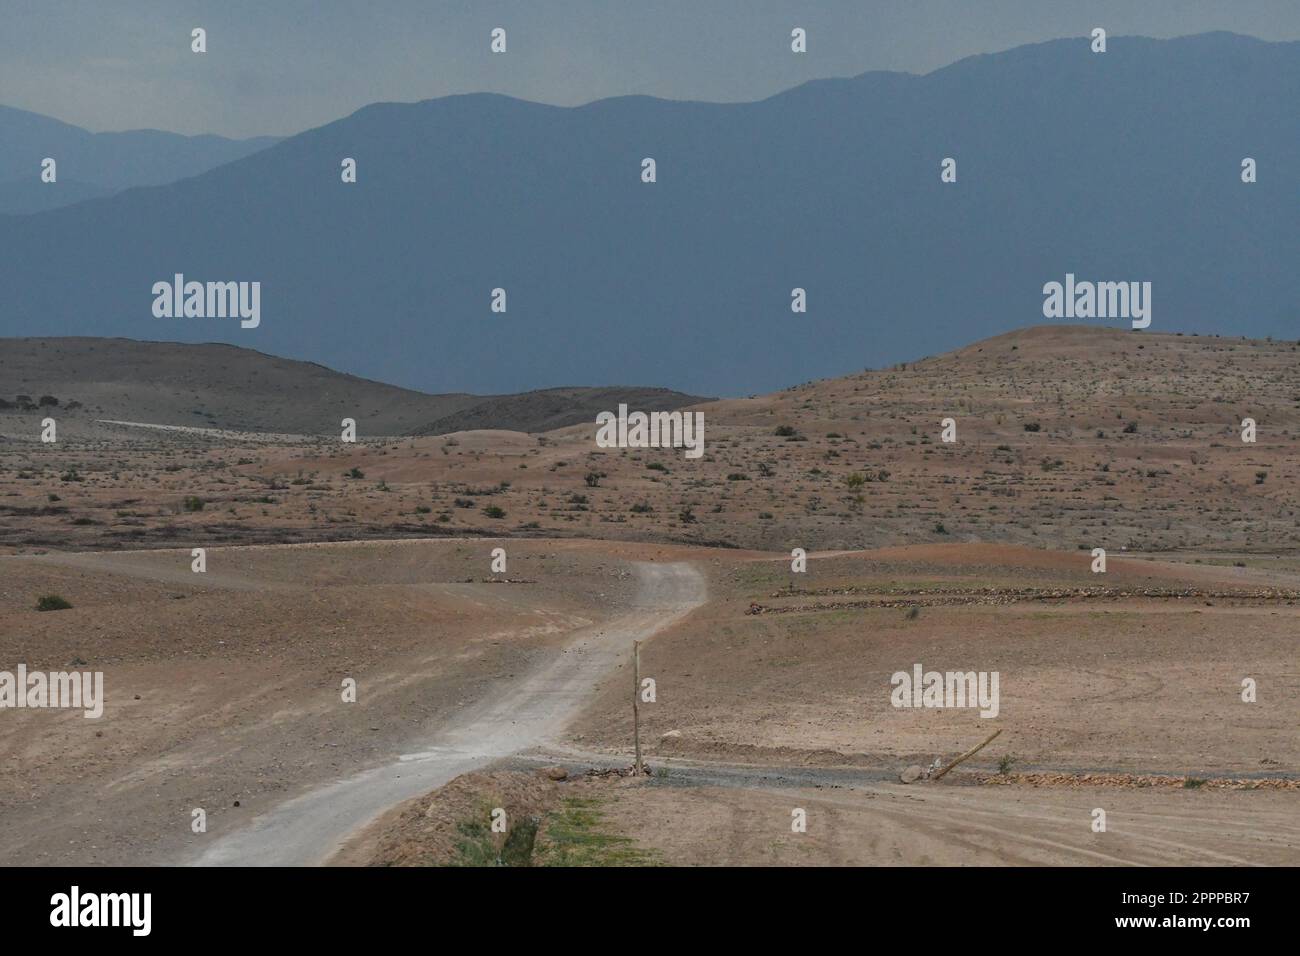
[0,541,670,864]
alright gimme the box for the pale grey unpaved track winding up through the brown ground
[191,563,706,866]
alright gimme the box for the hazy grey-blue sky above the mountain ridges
[0,0,1300,137]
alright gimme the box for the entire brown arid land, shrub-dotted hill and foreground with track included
[0,329,1300,865]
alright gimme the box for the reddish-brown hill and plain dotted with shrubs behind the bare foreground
[0,326,1300,557]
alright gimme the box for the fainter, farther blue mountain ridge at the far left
[0,107,280,213]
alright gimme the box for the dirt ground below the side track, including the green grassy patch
[332,766,1300,866]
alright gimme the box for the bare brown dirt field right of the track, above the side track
[571,545,1300,777]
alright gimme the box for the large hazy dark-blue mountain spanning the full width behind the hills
[0,34,1300,394]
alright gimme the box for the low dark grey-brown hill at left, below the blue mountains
[0,338,709,438]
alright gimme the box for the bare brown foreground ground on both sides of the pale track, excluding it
[0,540,1300,864]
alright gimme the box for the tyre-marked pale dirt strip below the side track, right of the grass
[603,783,1300,866]
